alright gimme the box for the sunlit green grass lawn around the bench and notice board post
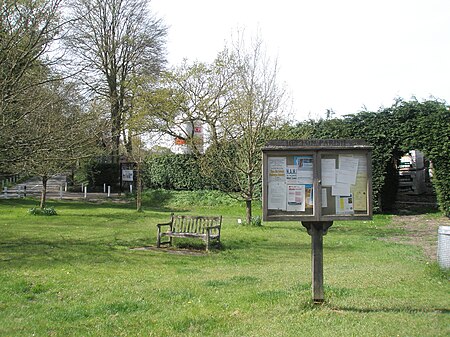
[0,191,450,336]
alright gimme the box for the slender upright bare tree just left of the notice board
[204,37,285,223]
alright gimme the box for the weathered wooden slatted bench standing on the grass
[156,214,222,251]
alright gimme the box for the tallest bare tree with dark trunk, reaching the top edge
[66,0,167,163]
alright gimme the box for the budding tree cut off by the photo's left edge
[0,0,61,171]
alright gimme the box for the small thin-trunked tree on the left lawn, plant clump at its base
[14,81,102,208]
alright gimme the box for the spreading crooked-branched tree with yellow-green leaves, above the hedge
[136,49,237,155]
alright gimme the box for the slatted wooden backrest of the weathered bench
[172,215,222,234]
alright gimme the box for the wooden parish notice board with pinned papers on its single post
[262,139,372,302]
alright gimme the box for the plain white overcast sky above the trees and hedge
[150,0,450,120]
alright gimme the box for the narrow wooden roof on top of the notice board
[262,139,373,151]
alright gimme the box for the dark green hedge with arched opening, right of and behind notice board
[290,100,450,216]
